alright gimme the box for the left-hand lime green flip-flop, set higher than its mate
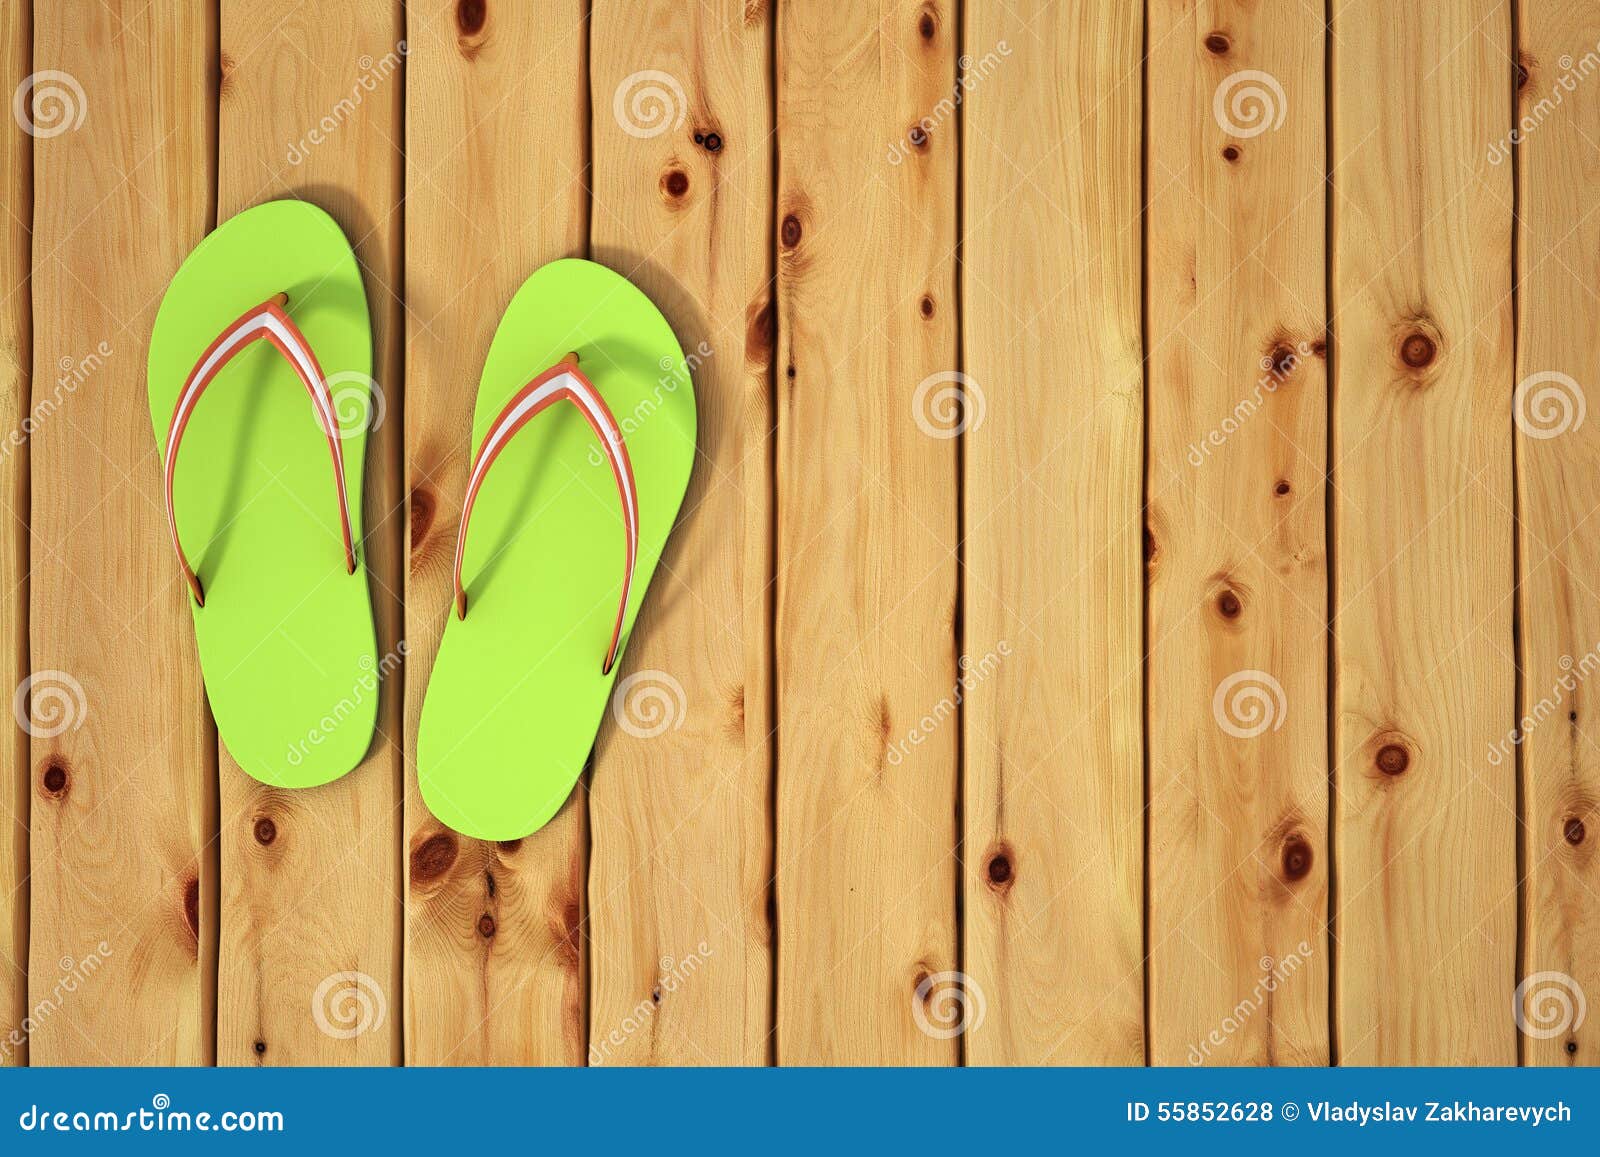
[149,200,382,787]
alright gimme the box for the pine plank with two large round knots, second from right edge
[1331,0,1517,1064]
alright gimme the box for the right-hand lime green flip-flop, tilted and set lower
[416,259,694,840]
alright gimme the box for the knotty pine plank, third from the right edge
[1147,0,1330,1064]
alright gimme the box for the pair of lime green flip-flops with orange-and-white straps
[149,200,694,840]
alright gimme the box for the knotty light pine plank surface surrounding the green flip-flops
[0,0,1600,1064]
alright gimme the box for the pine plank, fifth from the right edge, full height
[774,0,958,1064]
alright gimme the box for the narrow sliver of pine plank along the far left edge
[0,3,34,1064]
